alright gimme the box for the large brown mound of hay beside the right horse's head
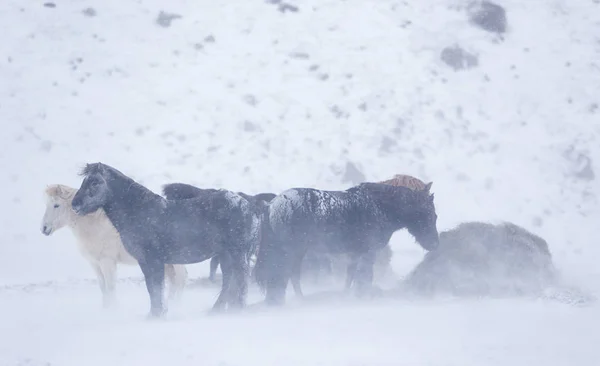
[402,222,557,297]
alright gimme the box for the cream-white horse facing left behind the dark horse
[41,184,187,308]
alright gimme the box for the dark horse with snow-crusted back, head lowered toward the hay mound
[255,183,439,305]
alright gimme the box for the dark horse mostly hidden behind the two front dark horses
[162,183,276,283]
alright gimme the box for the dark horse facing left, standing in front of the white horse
[72,163,254,318]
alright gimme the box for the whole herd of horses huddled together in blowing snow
[41,163,439,317]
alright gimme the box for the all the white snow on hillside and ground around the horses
[0,0,600,366]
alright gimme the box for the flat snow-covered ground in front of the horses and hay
[0,286,600,366]
